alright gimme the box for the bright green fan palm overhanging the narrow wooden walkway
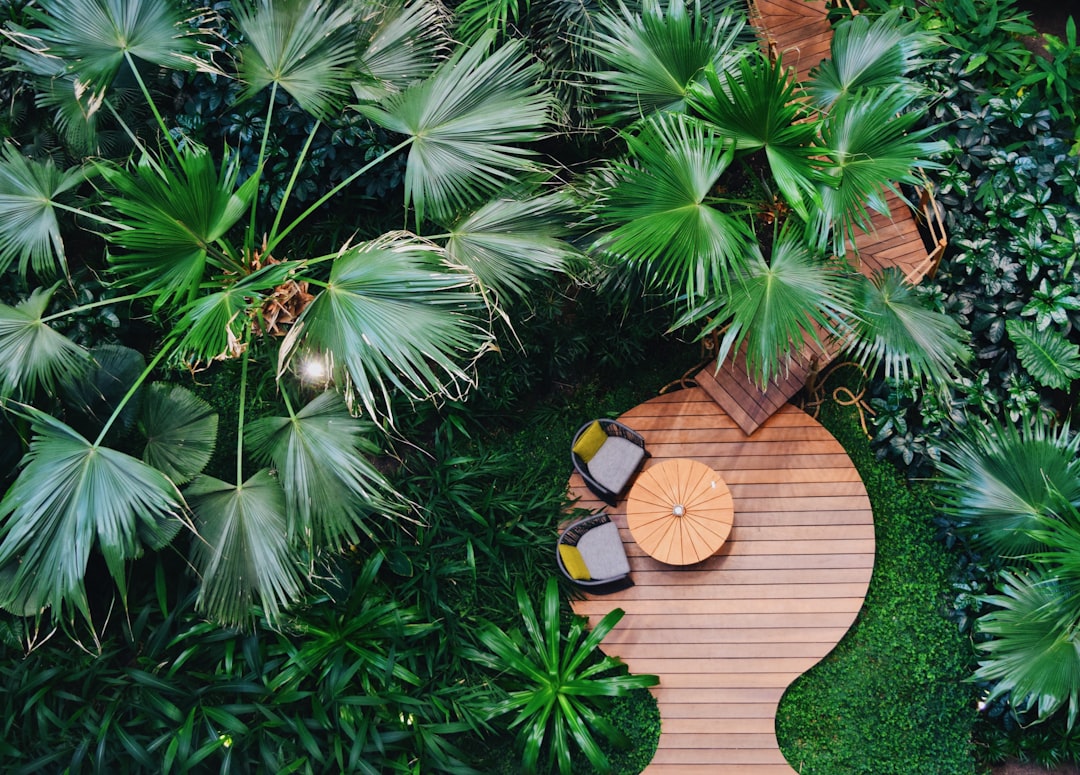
[594,7,970,384]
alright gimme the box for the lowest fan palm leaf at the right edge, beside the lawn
[974,571,1080,729]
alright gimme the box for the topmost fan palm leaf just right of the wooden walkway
[805,9,929,108]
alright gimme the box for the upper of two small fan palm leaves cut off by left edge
[0,144,85,277]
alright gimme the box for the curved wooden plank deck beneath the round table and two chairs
[570,388,874,775]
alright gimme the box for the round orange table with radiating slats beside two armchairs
[626,459,734,566]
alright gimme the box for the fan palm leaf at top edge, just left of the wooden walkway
[583,0,754,123]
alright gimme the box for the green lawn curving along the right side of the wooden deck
[777,405,978,775]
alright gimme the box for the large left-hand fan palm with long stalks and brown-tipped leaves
[0,0,571,624]
